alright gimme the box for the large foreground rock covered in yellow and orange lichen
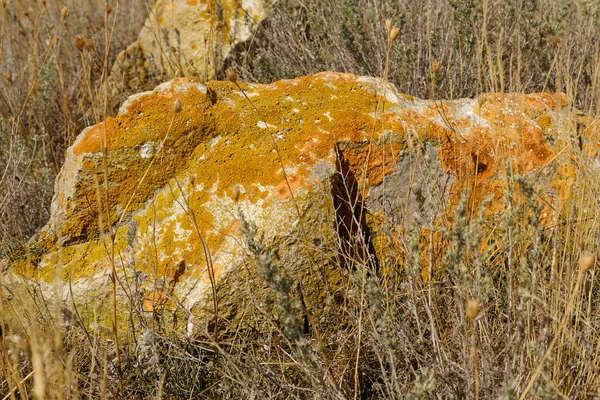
[11,73,597,332]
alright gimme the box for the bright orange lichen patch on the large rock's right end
[432,94,555,225]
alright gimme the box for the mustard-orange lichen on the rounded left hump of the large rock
[62,78,214,240]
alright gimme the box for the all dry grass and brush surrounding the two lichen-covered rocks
[0,0,600,399]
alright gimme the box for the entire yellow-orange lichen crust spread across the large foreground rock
[17,74,573,310]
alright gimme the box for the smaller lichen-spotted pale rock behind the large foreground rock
[110,0,270,103]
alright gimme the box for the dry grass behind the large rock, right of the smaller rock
[231,0,600,109]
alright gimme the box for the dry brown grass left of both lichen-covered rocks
[0,0,154,254]
